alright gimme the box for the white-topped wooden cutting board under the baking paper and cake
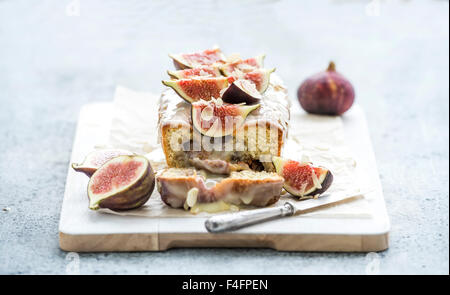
[59,103,390,252]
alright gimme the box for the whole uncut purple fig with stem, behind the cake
[297,62,355,115]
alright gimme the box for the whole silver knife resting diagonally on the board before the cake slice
[205,193,363,233]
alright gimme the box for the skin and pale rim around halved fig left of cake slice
[88,156,155,211]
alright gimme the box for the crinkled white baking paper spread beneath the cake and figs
[100,86,371,218]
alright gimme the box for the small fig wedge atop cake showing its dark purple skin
[222,79,262,104]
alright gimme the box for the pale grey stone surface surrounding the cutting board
[0,0,449,274]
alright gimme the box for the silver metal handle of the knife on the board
[205,202,295,233]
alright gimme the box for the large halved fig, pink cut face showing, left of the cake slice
[88,155,155,210]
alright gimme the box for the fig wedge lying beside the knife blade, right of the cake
[272,157,333,197]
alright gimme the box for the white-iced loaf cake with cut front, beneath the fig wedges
[158,74,290,173]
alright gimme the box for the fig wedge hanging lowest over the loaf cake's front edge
[191,99,260,137]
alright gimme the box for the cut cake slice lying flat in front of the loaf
[156,168,283,213]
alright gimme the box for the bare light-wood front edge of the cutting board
[59,232,389,252]
